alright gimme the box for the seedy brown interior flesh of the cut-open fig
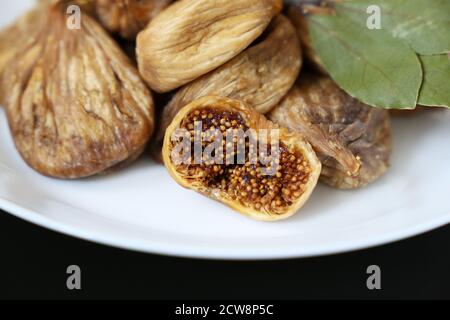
[171,107,311,214]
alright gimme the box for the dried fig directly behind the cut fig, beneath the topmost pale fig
[152,15,302,159]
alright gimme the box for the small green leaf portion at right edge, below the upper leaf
[419,54,450,107]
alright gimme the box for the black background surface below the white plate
[0,211,450,300]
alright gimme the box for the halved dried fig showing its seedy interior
[163,96,321,221]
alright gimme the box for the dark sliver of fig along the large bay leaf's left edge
[288,5,328,74]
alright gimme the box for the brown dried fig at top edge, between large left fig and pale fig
[94,0,172,40]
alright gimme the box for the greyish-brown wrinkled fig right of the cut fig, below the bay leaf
[269,74,391,189]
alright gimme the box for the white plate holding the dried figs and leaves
[0,1,450,259]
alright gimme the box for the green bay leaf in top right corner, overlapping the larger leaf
[337,0,450,55]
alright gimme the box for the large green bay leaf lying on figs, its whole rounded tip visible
[308,7,423,109]
